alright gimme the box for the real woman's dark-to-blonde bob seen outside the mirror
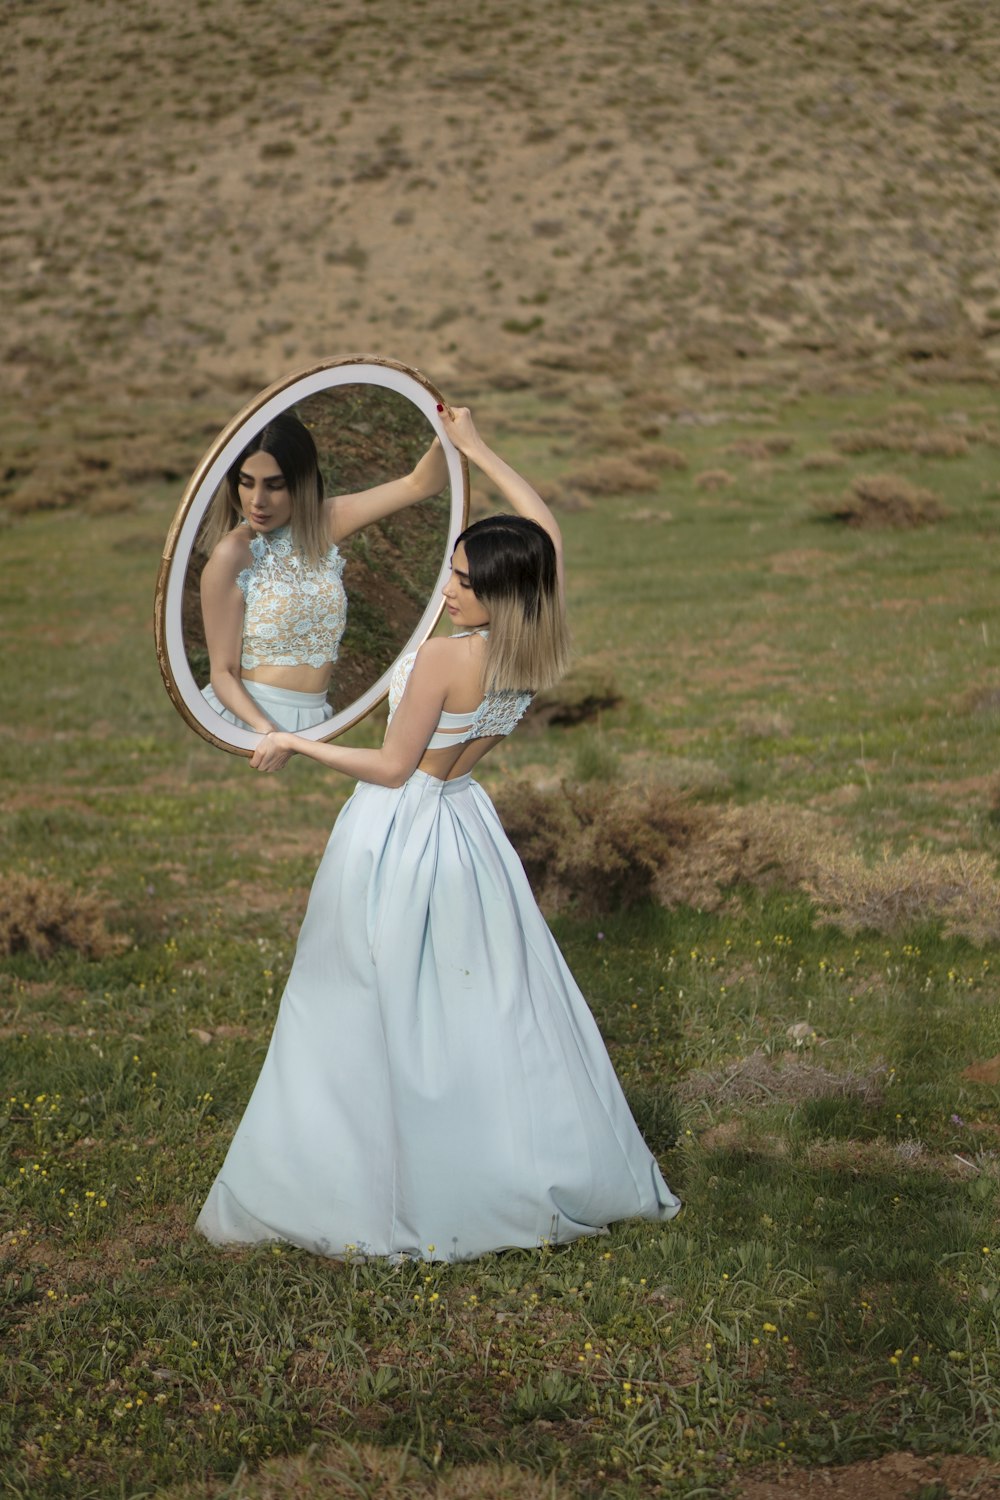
[456,516,570,693]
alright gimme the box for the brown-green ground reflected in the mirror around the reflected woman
[183,384,451,713]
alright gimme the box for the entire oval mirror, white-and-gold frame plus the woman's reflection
[154,357,468,755]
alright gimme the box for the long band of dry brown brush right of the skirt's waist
[496,782,1000,947]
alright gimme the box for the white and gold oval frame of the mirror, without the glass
[154,354,469,756]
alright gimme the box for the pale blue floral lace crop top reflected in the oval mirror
[237,525,348,668]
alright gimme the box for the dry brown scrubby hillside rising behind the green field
[0,0,1000,438]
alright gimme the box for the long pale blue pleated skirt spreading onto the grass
[198,771,681,1260]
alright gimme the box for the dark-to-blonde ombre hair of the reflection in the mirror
[199,411,330,567]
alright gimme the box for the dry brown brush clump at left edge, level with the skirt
[0,872,129,959]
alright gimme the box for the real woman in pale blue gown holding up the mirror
[198,410,679,1260]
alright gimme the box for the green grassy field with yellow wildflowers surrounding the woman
[0,380,1000,1500]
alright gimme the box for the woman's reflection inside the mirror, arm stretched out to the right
[201,411,448,735]
